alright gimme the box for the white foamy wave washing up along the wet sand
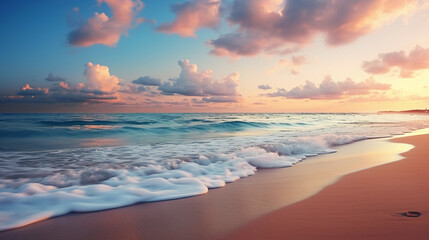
[0,135,368,230]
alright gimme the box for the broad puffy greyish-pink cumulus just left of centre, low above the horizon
[158,60,240,102]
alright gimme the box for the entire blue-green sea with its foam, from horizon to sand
[0,113,429,230]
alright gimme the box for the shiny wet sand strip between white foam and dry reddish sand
[0,132,424,239]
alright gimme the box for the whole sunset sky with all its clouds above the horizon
[0,0,429,112]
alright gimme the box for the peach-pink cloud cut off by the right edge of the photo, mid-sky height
[362,45,429,78]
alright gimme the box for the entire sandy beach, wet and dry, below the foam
[0,132,429,240]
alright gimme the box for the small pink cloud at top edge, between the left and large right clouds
[157,0,220,37]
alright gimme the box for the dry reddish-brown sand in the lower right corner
[225,135,429,240]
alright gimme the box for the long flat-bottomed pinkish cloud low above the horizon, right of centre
[267,76,391,100]
